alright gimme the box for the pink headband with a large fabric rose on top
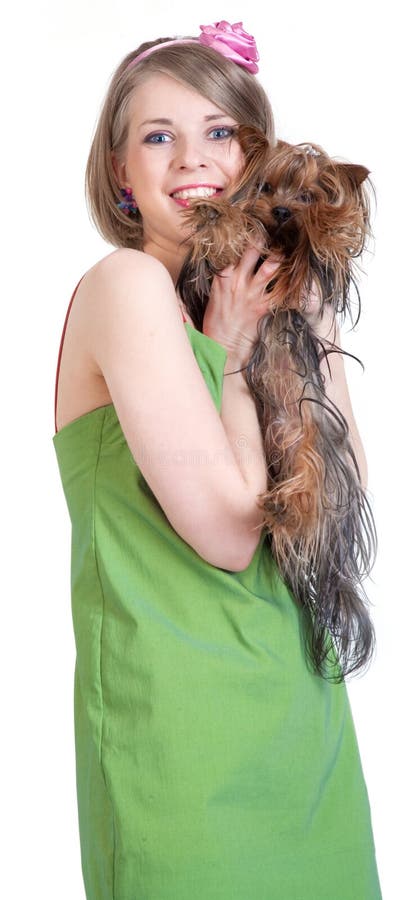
[127,22,260,75]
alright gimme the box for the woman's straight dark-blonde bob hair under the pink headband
[86,38,275,250]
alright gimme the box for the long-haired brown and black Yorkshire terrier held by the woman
[178,126,377,682]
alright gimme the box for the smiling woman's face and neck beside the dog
[115,73,244,252]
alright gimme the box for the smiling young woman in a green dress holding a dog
[54,22,381,900]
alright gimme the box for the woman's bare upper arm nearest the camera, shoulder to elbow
[83,250,276,571]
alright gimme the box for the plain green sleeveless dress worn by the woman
[53,324,381,900]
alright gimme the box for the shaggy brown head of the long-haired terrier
[252,141,370,310]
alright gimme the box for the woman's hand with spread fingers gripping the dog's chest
[203,246,277,365]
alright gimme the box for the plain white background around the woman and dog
[0,0,418,900]
